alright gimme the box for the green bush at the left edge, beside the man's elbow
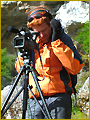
[1,48,16,88]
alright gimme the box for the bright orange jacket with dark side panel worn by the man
[15,39,83,98]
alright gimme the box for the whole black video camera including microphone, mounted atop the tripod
[8,26,39,52]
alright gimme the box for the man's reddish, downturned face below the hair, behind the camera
[32,22,51,43]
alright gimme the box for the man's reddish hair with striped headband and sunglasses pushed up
[26,5,52,28]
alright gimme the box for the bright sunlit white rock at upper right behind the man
[55,1,89,34]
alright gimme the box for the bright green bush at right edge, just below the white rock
[74,22,89,54]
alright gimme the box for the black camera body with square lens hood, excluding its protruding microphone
[13,31,32,52]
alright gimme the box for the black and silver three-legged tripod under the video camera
[1,52,51,119]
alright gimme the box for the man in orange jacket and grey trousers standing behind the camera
[15,6,83,119]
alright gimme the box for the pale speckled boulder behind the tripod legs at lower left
[1,85,23,119]
